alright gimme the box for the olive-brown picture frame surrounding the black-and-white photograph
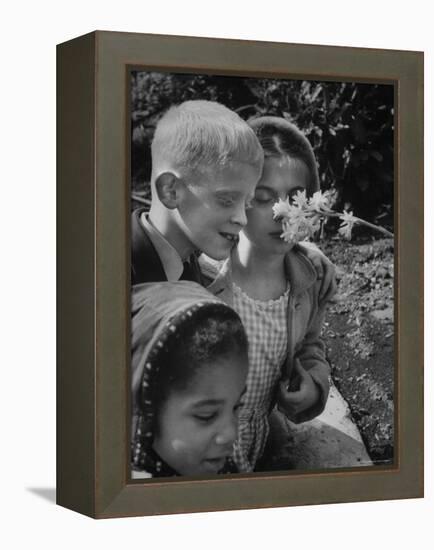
[57,31,423,518]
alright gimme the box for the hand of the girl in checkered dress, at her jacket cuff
[277,359,320,420]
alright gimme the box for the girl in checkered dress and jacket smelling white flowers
[202,117,335,471]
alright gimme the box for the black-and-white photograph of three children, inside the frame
[128,68,396,481]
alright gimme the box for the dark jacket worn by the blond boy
[131,208,201,285]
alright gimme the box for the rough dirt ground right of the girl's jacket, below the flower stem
[320,239,394,464]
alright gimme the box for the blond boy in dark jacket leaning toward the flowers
[131,100,263,284]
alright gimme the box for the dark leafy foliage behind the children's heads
[131,72,394,230]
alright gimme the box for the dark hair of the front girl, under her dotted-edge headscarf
[151,304,248,417]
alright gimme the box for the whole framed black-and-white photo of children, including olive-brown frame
[57,31,423,518]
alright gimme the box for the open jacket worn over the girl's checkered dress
[199,246,336,423]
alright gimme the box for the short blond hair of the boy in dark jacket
[152,100,263,175]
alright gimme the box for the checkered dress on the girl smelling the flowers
[233,283,289,472]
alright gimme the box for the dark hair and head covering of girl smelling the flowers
[248,116,319,195]
